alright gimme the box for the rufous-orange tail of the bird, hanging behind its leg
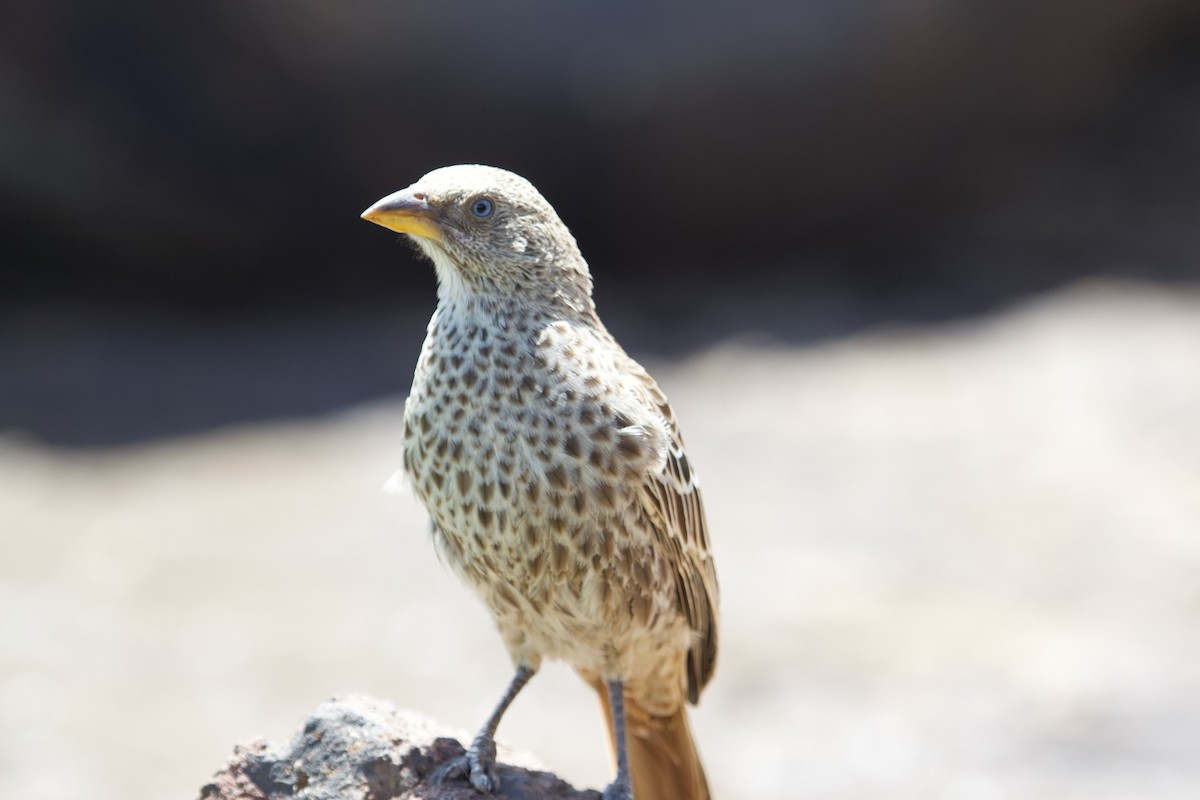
[584,678,710,800]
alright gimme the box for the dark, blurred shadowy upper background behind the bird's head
[0,0,1200,444]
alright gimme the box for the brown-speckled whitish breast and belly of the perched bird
[404,309,654,638]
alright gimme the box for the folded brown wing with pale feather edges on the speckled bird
[635,367,718,703]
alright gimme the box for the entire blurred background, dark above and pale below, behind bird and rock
[0,0,1200,800]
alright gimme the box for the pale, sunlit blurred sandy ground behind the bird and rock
[0,280,1200,800]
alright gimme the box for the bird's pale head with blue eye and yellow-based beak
[362,164,592,305]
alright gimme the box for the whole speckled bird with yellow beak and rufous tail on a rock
[361,164,718,800]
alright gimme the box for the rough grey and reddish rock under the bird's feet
[199,694,600,800]
